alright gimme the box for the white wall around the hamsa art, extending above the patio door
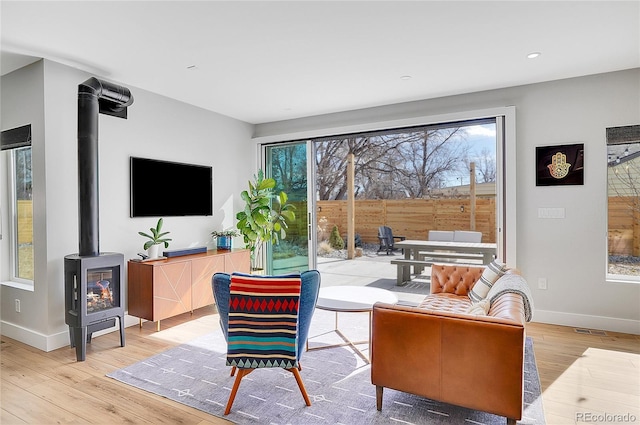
[254,69,640,334]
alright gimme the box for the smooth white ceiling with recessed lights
[0,0,640,124]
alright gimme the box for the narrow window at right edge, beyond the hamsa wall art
[607,125,640,282]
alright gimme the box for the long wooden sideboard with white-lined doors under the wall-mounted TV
[127,249,250,330]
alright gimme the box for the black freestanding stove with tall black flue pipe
[64,78,133,361]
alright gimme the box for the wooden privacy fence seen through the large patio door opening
[316,198,496,244]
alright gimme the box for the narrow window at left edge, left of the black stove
[2,125,34,284]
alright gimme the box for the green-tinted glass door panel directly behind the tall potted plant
[264,142,315,274]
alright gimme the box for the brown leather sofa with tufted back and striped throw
[371,264,526,424]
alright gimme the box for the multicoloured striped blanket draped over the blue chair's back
[227,273,301,369]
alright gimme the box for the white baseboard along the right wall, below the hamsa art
[533,310,640,335]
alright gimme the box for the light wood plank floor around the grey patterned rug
[0,307,640,425]
